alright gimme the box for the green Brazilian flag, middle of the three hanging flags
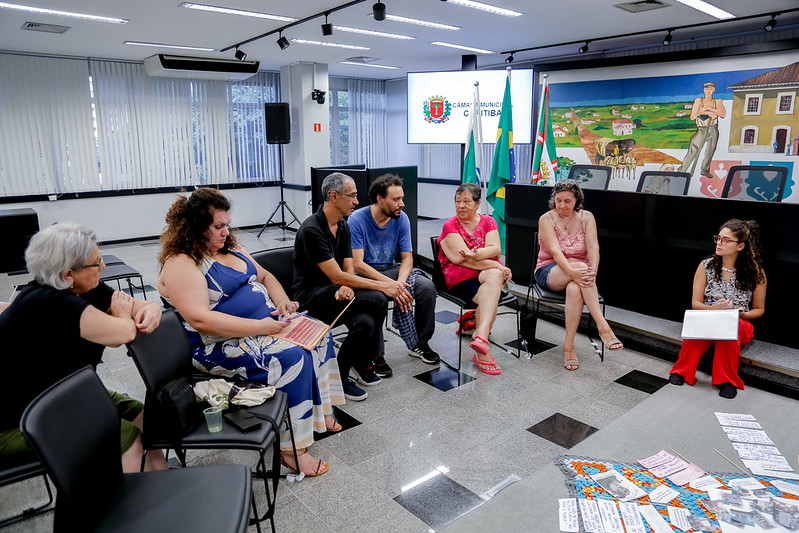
[486,68,516,254]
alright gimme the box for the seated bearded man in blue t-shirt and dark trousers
[348,174,440,370]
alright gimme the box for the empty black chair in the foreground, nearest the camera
[21,366,253,533]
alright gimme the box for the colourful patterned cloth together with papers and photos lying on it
[555,455,799,533]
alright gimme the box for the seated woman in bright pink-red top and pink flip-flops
[438,183,512,375]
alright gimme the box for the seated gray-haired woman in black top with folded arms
[0,223,167,472]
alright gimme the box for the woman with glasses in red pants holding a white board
[669,219,766,398]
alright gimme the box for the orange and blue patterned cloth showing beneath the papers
[554,455,797,533]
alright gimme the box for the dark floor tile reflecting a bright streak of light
[394,473,485,529]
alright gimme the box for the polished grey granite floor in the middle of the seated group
[0,220,715,532]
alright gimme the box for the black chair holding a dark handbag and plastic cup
[128,310,296,531]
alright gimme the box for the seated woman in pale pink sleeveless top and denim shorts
[535,180,624,370]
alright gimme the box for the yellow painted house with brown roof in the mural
[729,62,799,153]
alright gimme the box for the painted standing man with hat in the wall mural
[680,81,727,178]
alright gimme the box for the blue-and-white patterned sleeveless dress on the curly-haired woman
[183,250,345,449]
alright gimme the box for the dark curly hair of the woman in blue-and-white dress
[158,187,238,266]
